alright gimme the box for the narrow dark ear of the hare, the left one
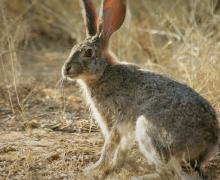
[81,0,98,36]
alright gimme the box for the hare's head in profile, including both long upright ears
[62,0,126,81]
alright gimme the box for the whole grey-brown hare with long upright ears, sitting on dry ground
[62,0,219,178]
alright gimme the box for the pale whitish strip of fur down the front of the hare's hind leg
[136,116,162,168]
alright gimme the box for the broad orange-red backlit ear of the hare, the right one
[99,0,126,43]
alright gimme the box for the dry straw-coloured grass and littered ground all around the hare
[0,0,220,179]
